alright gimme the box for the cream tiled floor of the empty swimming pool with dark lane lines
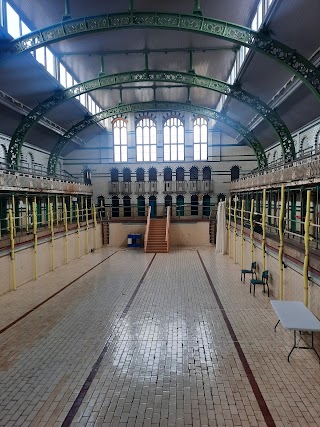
[0,248,320,427]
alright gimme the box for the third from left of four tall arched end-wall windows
[163,117,184,162]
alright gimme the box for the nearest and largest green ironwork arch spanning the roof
[8,10,320,100]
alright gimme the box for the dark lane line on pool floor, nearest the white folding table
[197,251,276,427]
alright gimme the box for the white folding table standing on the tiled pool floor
[271,301,320,362]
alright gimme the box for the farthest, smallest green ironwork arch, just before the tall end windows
[48,101,267,176]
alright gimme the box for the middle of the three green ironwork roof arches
[8,70,295,167]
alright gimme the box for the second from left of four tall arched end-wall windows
[136,118,157,162]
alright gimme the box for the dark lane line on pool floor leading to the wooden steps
[61,254,156,427]
